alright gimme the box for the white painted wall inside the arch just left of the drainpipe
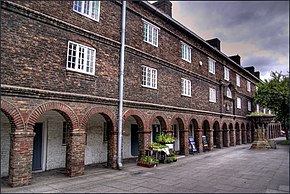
[85,114,108,165]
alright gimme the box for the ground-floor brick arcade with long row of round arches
[1,100,280,187]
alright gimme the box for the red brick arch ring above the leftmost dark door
[26,102,79,130]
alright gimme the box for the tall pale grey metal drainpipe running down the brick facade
[117,1,126,170]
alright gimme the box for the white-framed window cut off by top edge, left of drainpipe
[73,1,100,21]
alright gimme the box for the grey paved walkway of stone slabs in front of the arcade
[1,137,289,193]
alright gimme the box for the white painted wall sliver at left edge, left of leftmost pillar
[1,112,11,177]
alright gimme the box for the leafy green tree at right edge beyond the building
[254,72,290,139]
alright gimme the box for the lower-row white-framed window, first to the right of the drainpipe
[142,66,157,89]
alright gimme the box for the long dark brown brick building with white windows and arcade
[1,1,278,186]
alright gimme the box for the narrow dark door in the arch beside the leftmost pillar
[32,123,42,171]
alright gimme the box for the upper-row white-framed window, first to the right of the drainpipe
[142,19,160,47]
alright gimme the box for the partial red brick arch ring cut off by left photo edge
[1,100,25,133]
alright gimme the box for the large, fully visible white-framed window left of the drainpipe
[66,41,96,75]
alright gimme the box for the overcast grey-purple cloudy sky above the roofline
[162,1,289,80]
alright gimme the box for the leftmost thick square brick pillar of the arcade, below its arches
[8,130,35,187]
